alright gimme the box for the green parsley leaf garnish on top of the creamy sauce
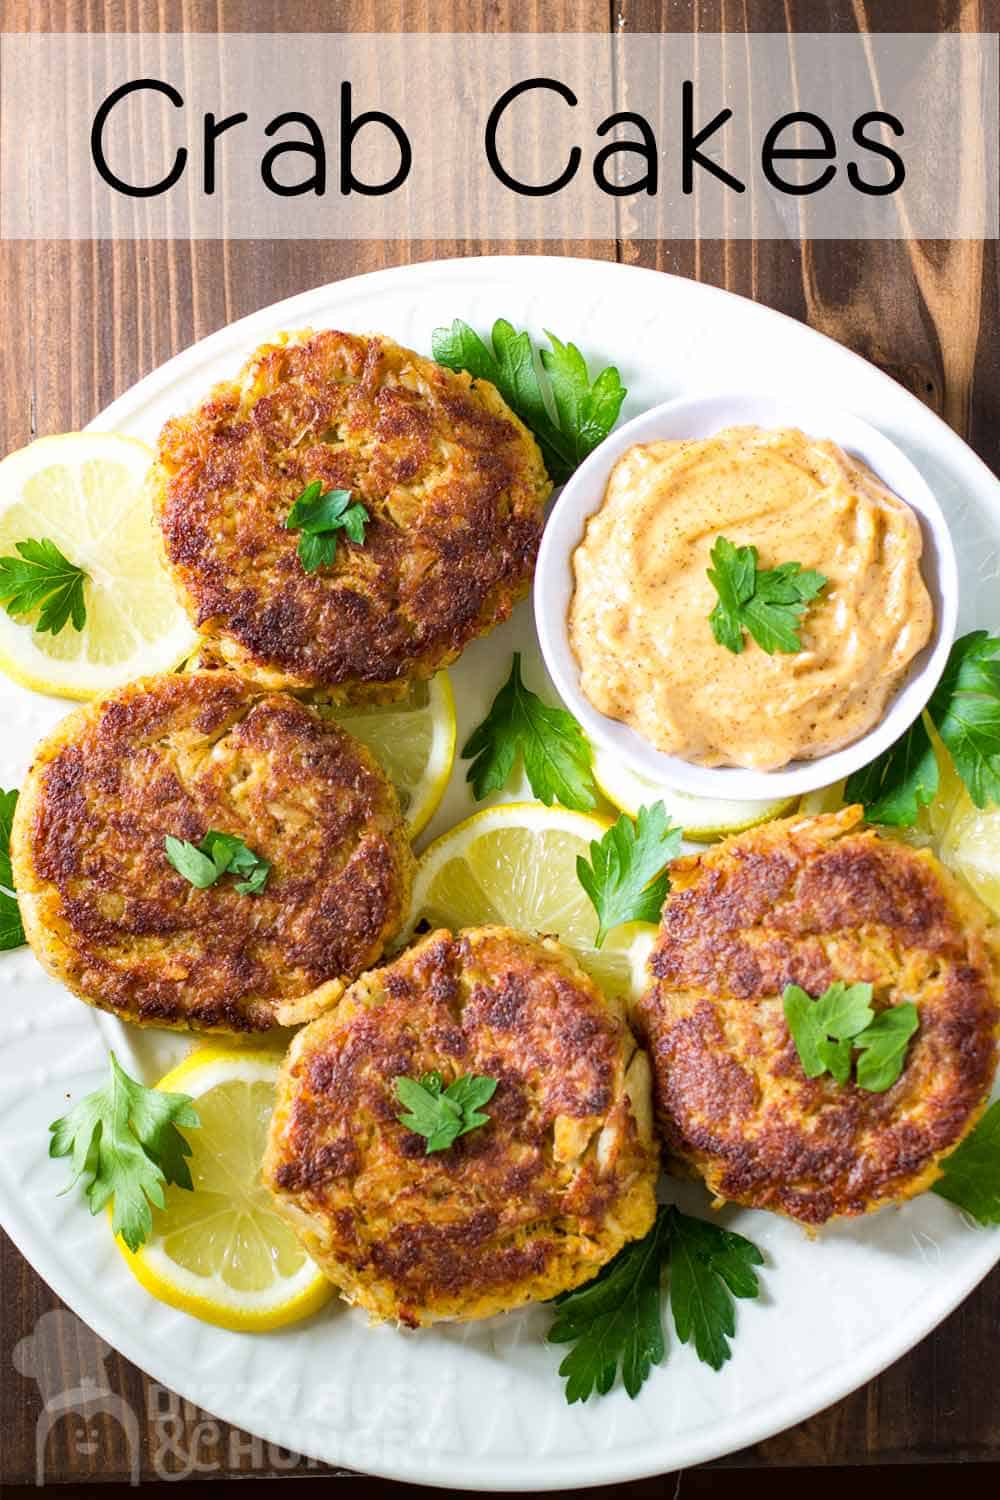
[708,537,829,656]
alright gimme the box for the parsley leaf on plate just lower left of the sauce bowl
[462,651,597,812]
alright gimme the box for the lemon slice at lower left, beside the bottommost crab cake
[117,1047,333,1334]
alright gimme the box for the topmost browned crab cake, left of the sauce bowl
[151,332,552,699]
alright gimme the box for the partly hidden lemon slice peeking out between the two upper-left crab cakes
[324,672,454,839]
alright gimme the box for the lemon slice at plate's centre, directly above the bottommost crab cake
[403,803,655,996]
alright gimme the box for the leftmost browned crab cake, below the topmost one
[10,672,412,1032]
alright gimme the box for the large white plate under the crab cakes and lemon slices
[0,257,1000,1491]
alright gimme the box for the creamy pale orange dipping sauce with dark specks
[570,428,934,771]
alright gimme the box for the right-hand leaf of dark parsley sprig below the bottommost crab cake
[661,1208,763,1370]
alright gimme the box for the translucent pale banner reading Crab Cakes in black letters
[0,33,1000,240]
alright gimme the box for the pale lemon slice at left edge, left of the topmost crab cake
[0,432,196,698]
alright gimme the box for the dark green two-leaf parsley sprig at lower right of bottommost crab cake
[547,1206,763,1403]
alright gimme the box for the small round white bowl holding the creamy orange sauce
[534,393,958,798]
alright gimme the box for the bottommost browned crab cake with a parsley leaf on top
[264,927,657,1326]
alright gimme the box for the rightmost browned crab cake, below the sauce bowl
[637,807,1000,1226]
